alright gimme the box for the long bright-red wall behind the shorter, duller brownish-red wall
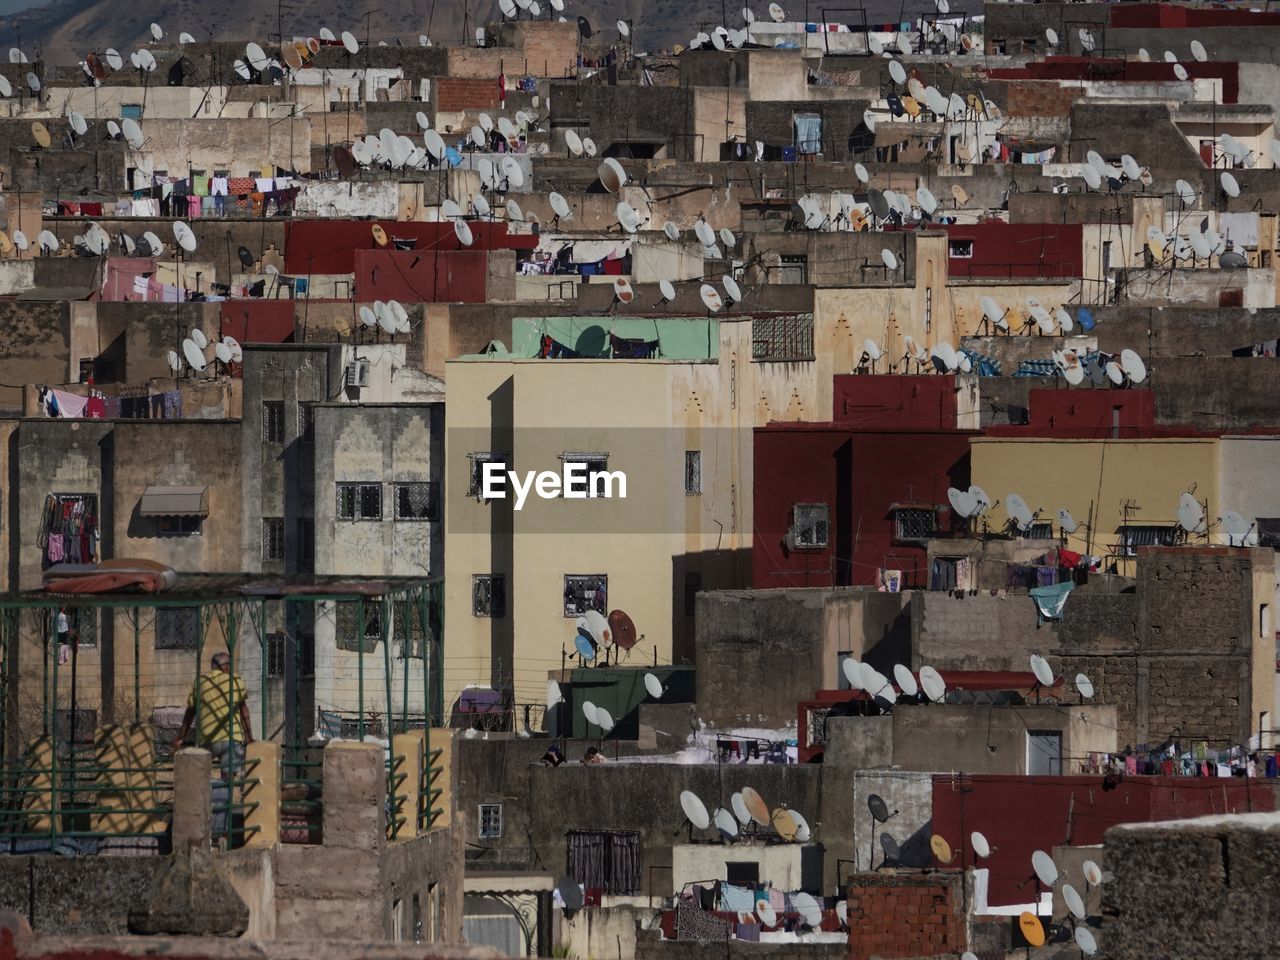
[284,220,538,276]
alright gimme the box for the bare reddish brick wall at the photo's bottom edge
[849,874,965,960]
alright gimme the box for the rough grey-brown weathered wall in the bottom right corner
[1100,813,1280,960]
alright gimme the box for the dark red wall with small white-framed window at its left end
[946,220,1084,276]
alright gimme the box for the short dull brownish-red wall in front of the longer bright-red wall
[355,250,489,303]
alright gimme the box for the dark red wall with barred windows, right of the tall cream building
[751,430,969,589]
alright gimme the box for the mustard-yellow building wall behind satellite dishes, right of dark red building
[970,436,1229,563]
